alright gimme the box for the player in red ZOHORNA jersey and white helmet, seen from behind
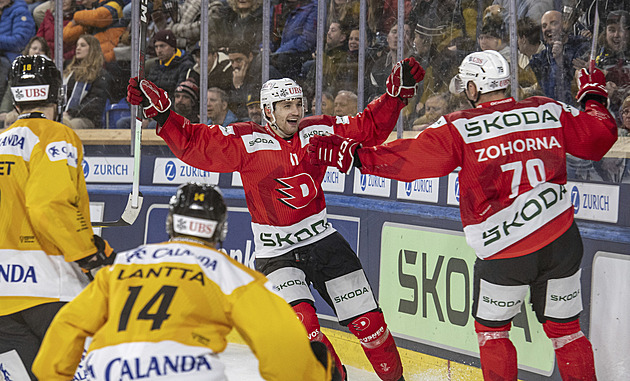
[309,50,617,381]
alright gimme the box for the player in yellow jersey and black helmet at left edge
[0,55,115,379]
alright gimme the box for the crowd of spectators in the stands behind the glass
[0,0,630,181]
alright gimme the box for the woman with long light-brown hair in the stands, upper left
[63,34,112,130]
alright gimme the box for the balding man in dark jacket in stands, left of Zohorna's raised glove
[529,11,590,105]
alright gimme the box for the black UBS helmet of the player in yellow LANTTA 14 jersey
[166,183,227,242]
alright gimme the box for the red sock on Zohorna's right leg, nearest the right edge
[543,319,597,381]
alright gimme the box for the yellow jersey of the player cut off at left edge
[0,112,96,316]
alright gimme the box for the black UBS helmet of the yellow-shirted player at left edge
[9,55,65,111]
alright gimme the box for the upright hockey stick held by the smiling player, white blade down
[92,0,149,227]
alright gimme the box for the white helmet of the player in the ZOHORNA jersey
[449,50,510,94]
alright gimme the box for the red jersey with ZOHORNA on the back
[357,97,617,259]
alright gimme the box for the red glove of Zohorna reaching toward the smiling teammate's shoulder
[308,135,361,175]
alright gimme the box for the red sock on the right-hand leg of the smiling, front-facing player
[348,312,402,381]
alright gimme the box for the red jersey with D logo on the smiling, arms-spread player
[157,94,404,257]
